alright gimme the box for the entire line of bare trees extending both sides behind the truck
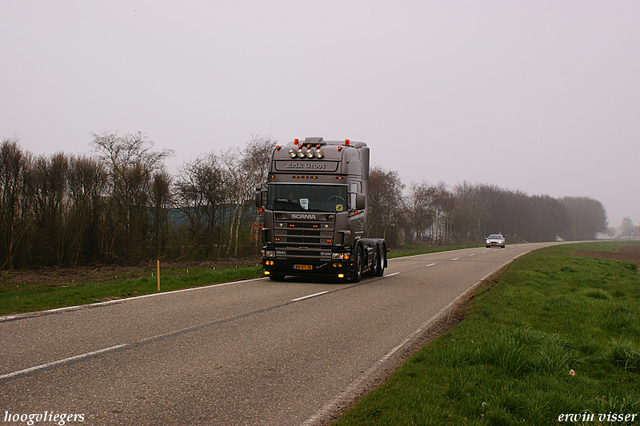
[0,133,607,269]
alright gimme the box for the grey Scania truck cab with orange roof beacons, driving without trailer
[256,137,388,282]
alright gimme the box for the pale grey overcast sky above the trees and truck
[0,0,640,230]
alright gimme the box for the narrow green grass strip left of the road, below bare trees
[0,266,262,315]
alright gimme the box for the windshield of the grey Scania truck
[267,184,348,213]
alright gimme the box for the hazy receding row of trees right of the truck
[368,167,607,245]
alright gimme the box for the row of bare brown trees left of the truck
[0,133,274,269]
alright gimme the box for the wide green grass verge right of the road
[336,243,640,426]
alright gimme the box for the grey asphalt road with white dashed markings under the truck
[0,244,548,425]
